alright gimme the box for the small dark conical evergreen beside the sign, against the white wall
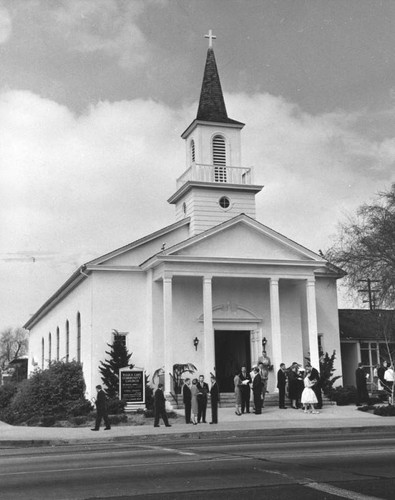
[99,330,134,398]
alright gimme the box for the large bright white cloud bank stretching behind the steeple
[0,91,395,324]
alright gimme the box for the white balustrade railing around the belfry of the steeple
[177,163,253,189]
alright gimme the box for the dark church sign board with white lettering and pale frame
[119,367,145,411]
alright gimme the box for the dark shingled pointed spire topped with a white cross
[196,30,243,123]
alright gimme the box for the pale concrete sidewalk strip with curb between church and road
[0,406,395,448]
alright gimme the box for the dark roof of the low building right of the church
[339,309,395,341]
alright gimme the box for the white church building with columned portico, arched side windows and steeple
[25,33,342,395]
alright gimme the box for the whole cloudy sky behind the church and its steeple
[0,0,395,332]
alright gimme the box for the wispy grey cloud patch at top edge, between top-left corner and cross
[51,0,161,69]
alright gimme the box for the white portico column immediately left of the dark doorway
[203,276,215,380]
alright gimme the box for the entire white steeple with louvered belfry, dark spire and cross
[168,30,263,236]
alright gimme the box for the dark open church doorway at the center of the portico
[215,330,251,392]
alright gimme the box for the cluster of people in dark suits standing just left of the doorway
[182,375,220,425]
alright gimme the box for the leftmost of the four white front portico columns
[163,276,174,394]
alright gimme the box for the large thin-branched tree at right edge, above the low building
[325,184,395,308]
